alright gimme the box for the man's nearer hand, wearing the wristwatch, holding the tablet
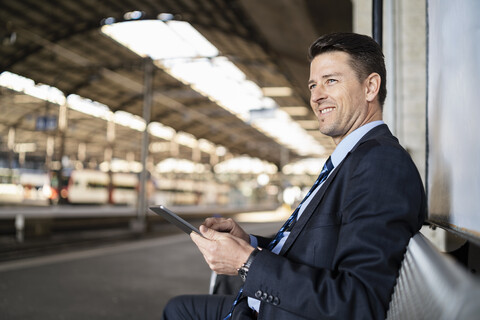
[190,225,254,275]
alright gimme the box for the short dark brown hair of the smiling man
[308,33,387,106]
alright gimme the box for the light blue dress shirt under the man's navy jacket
[248,120,384,312]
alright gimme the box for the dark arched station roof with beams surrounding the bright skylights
[0,0,352,165]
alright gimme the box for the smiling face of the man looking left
[308,51,378,144]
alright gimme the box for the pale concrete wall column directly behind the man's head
[352,0,426,181]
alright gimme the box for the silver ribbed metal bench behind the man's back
[387,233,480,320]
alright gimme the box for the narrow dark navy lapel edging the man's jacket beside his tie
[279,124,393,255]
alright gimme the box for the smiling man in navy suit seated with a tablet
[164,33,425,320]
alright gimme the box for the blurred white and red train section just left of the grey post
[52,170,139,205]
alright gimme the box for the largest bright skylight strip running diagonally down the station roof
[102,20,324,155]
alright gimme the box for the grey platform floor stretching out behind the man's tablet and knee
[0,222,281,320]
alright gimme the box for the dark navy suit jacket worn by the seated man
[244,125,426,320]
